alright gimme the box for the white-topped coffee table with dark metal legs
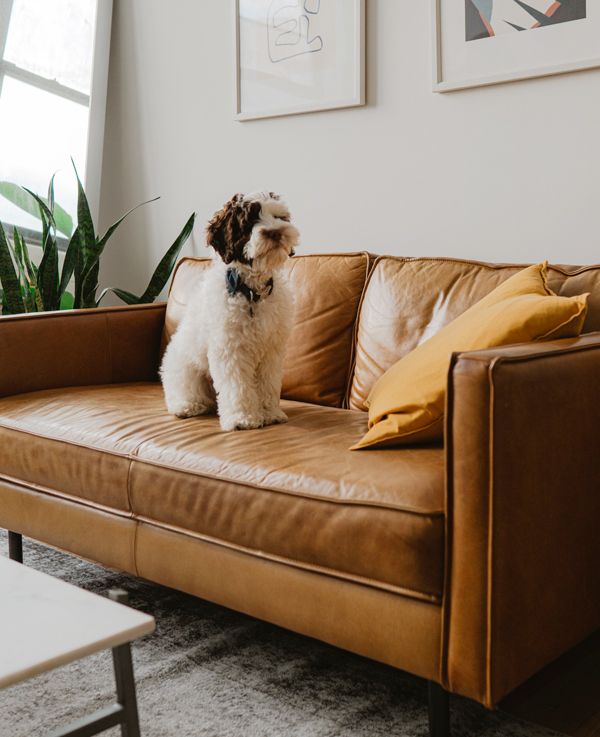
[0,557,155,737]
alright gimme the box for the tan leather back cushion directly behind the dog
[163,253,369,407]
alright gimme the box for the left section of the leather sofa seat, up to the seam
[0,383,179,514]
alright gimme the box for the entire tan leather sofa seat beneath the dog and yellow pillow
[0,383,444,602]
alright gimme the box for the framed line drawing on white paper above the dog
[234,0,365,120]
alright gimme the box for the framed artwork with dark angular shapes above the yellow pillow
[432,0,600,92]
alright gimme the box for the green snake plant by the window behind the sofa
[0,165,195,315]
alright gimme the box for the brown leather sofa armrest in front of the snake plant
[0,304,165,397]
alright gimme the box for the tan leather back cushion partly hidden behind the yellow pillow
[349,256,600,410]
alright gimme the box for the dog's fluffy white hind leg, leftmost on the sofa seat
[161,334,215,417]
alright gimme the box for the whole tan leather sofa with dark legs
[0,253,600,735]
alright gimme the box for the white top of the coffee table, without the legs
[0,557,155,688]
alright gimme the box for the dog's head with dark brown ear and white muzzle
[206,192,300,272]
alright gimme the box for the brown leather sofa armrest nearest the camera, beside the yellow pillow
[442,333,600,706]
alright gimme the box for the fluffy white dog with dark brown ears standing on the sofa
[160,192,299,432]
